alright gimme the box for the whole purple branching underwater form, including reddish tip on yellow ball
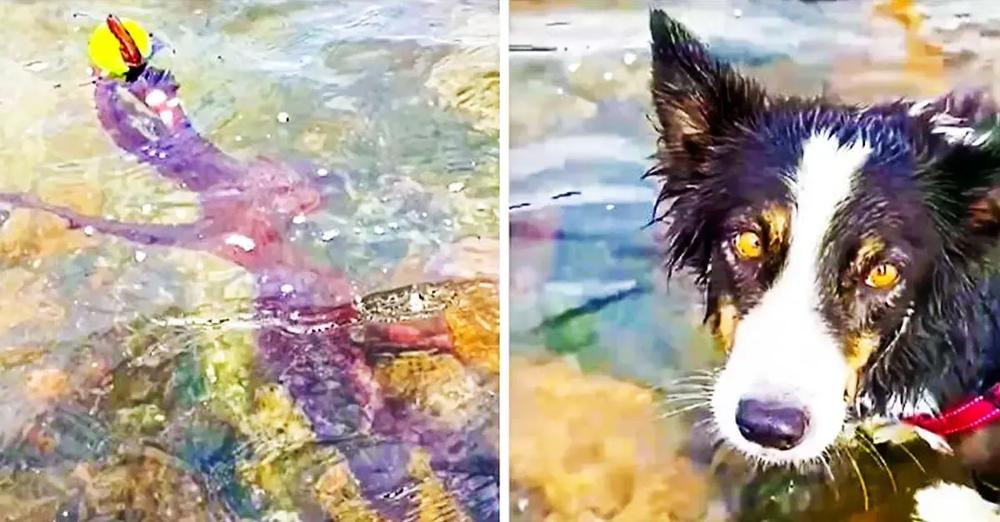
[0,16,500,521]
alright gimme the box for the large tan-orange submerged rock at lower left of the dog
[510,357,709,522]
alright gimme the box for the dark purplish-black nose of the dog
[736,399,809,450]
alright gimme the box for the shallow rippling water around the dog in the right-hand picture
[510,0,1000,520]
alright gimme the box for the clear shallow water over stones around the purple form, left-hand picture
[0,1,499,520]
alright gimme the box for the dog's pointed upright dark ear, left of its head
[649,10,767,174]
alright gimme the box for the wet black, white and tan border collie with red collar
[647,11,1000,518]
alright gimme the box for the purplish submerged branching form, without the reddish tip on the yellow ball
[0,67,499,521]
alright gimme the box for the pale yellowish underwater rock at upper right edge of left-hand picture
[426,46,500,133]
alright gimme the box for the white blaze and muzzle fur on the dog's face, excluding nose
[712,133,871,463]
